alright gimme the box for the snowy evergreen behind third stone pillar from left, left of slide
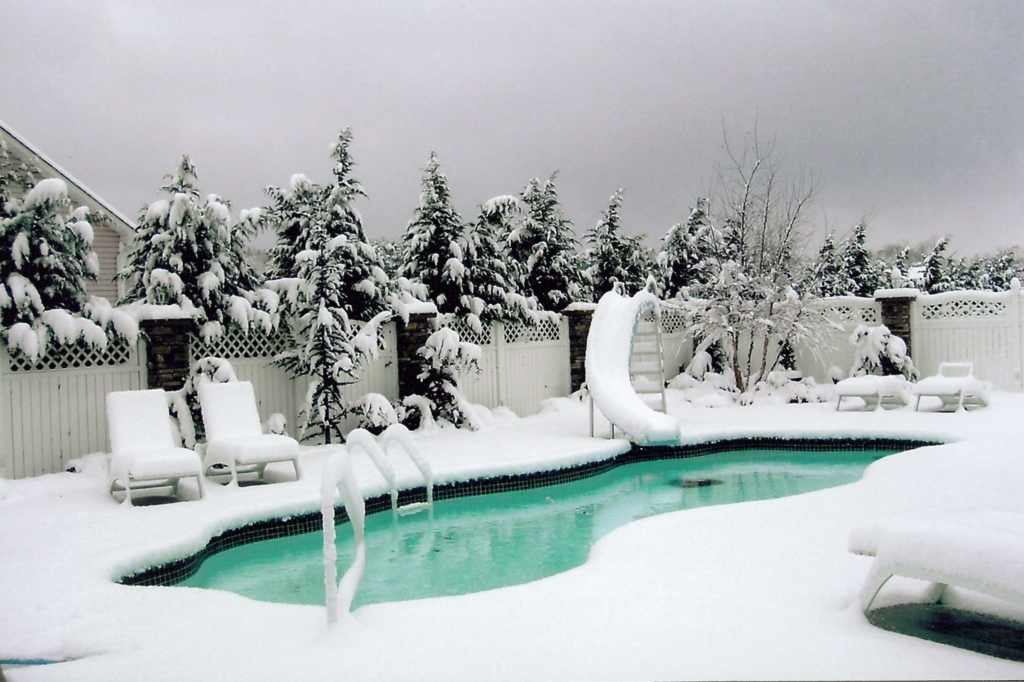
[508,173,590,312]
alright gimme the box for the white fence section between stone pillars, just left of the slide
[441,315,569,417]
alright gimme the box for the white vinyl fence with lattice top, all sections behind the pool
[0,285,1024,478]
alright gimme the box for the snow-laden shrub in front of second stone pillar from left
[409,327,481,431]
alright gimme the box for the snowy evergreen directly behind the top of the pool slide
[585,189,651,299]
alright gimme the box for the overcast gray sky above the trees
[0,0,1024,254]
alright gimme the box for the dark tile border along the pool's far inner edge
[118,437,939,586]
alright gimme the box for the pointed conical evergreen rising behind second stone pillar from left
[399,153,468,313]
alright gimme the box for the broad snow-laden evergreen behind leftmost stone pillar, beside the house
[118,156,258,338]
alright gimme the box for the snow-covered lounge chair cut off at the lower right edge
[849,511,1024,613]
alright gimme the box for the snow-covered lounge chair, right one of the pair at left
[199,381,300,484]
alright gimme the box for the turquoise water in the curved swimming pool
[178,451,894,606]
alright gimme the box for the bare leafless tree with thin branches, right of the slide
[682,124,828,391]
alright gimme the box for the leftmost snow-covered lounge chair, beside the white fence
[106,388,203,505]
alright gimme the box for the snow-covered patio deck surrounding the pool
[0,393,1024,682]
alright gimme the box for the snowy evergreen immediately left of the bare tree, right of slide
[657,198,713,298]
